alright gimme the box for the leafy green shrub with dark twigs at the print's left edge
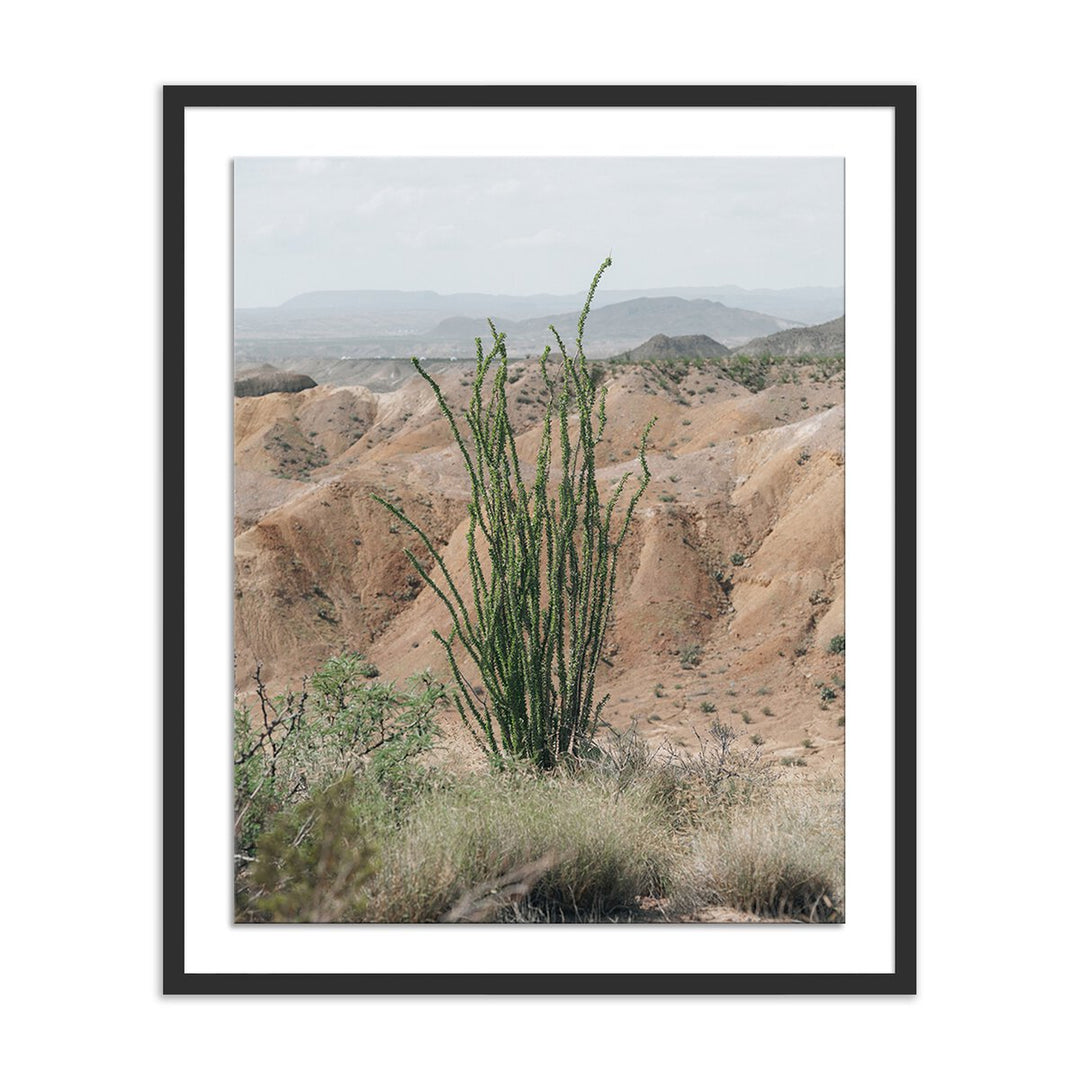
[233,652,444,865]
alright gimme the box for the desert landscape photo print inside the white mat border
[233,158,846,924]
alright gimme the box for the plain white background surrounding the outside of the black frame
[6,0,1078,1078]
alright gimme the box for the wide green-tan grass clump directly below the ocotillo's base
[363,771,673,922]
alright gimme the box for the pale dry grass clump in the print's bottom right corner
[672,779,843,922]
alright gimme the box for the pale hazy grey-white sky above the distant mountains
[234,158,843,307]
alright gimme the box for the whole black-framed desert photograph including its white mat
[163,85,916,995]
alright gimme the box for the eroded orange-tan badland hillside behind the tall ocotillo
[235,357,845,768]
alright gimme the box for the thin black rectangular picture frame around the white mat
[162,85,916,995]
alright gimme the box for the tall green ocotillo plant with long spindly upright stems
[375,258,654,768]
